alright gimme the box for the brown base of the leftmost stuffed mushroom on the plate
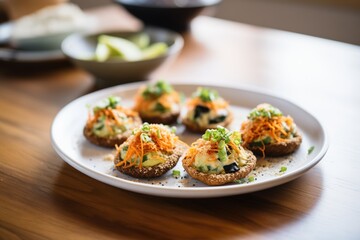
[83,117,142,148]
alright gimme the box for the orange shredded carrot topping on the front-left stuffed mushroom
[116,124,180,169]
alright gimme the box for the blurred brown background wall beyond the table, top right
[215,0,360,45]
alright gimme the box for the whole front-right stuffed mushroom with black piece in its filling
[182,126,256,185]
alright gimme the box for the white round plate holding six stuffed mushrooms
[51,83,328,198]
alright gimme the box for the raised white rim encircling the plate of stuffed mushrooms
[50,81,329,198]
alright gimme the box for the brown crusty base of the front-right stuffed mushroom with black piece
[183,150,256,186]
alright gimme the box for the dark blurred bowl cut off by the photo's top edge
[114,0,221,31]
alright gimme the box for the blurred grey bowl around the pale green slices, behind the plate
[61,27,184,86]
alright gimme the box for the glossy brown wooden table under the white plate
[0,4,360,239]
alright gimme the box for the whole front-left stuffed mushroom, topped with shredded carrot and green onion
[114,123,188,178]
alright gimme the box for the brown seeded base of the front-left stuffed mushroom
[114,141,188,178]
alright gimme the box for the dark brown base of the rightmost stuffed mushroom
[244,134,302,157]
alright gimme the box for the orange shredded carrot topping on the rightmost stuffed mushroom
[241,116,293,152]
